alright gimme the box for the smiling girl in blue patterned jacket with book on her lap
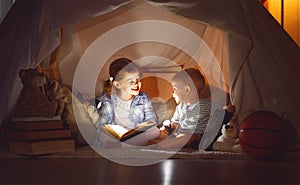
[93,58,159,147]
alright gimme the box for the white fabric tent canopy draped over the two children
[0,0,300,149]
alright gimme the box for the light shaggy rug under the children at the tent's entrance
[0,146,300,160]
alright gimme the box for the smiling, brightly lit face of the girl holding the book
[114,71,141,100]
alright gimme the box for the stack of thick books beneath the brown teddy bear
[5,117,75,156]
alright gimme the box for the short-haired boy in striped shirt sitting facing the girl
[148,68,211,149]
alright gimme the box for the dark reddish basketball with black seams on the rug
[239,111,289,159]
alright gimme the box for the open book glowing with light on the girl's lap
[102,121,156,141]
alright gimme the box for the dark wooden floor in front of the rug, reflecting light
[0,158,300,185]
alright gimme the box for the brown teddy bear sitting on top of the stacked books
[13,69,58,118]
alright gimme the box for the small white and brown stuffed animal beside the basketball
[212,116,243,153]
